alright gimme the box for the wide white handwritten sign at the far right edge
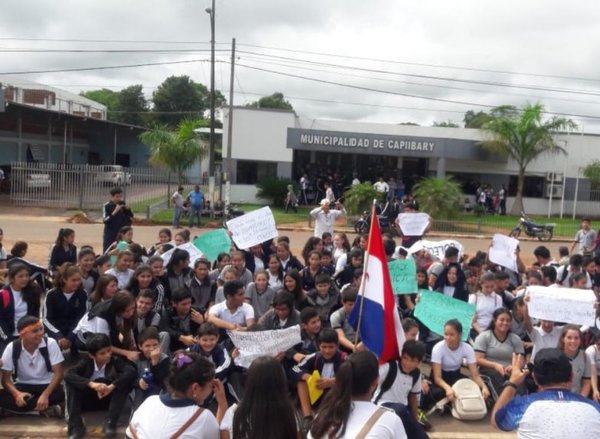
[526,286,596,326]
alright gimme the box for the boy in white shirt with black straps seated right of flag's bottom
[373,340,427,439]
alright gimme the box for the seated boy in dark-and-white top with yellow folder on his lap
[293,328,346,420]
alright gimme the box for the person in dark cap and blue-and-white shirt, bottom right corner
[491,348,600,439]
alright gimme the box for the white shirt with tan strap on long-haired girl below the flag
[308,401,406,439]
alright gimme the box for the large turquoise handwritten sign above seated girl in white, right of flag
[415,291,475,341]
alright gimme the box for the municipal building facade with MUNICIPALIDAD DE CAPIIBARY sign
[223,107,600,215]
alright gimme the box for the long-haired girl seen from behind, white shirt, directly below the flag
[308,351,406,439]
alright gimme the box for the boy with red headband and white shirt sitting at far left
[0,316,65,416]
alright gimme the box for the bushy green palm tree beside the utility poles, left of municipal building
[140,119,207,185]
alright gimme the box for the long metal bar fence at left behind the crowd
[5,162,206,213]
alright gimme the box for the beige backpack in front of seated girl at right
[428,378,487,421]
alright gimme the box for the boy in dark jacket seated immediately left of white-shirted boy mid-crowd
[160,288,204,353]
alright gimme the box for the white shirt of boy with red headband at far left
[2,338,64,384]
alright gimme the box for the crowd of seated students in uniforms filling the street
[0,188,600,439]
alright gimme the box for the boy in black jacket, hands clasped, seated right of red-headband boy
[65,334,136,439]
